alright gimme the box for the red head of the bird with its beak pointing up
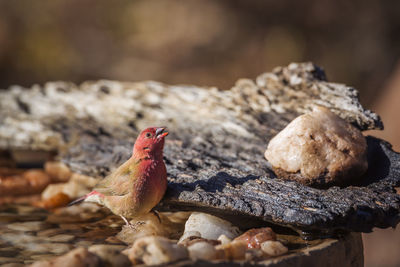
[133,127,168,157]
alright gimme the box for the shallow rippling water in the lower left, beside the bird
[0,204,124,265]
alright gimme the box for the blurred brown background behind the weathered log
[0,0,400,266]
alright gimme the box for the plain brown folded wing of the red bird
[93,158,138,196]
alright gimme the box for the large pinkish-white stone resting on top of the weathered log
[265,107,368,186]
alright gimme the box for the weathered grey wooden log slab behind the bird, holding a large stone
[0,63,400,239]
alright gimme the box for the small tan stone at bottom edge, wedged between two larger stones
[89,245,131,267]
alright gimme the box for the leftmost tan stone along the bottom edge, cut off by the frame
[31,248,101,267]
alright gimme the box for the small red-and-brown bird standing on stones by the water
[69,127,168,226]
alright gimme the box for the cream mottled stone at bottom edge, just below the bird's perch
[125,236,188,265]
